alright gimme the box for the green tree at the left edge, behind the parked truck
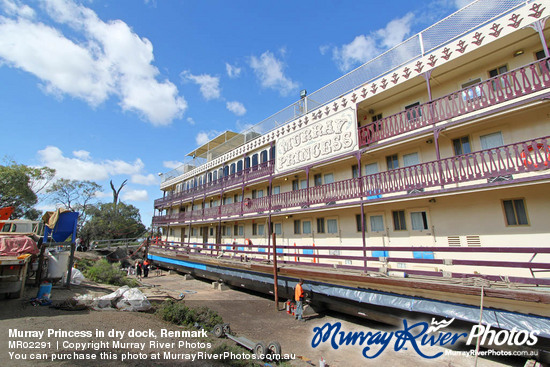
[0,159,55,220]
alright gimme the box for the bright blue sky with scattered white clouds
[0,0,468,226]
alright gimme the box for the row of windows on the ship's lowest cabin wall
[170,198,529,237]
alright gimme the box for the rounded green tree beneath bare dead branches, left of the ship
[80,202,146,243]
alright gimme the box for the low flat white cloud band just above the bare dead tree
[38,146,144,181]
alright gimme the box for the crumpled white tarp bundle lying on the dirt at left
[75,285,151,311]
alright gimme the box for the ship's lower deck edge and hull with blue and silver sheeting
[149,246,550,338]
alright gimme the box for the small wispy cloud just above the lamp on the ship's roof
[250,51,298,96]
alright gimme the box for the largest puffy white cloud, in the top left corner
[0,0,187,125]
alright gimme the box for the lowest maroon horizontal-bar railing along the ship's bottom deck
[152,242,550,286]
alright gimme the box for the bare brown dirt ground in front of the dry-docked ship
[0,272,544,367]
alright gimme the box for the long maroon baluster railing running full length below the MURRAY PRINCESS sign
[153,137,550,225]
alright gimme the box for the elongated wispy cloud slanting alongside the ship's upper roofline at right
[332,13,414,72]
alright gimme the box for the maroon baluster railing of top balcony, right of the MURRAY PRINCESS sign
[359,58,550,146]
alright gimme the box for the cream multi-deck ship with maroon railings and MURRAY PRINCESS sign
[148,0,550,337]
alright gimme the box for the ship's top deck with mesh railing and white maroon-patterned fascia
[161,0,544,189]
